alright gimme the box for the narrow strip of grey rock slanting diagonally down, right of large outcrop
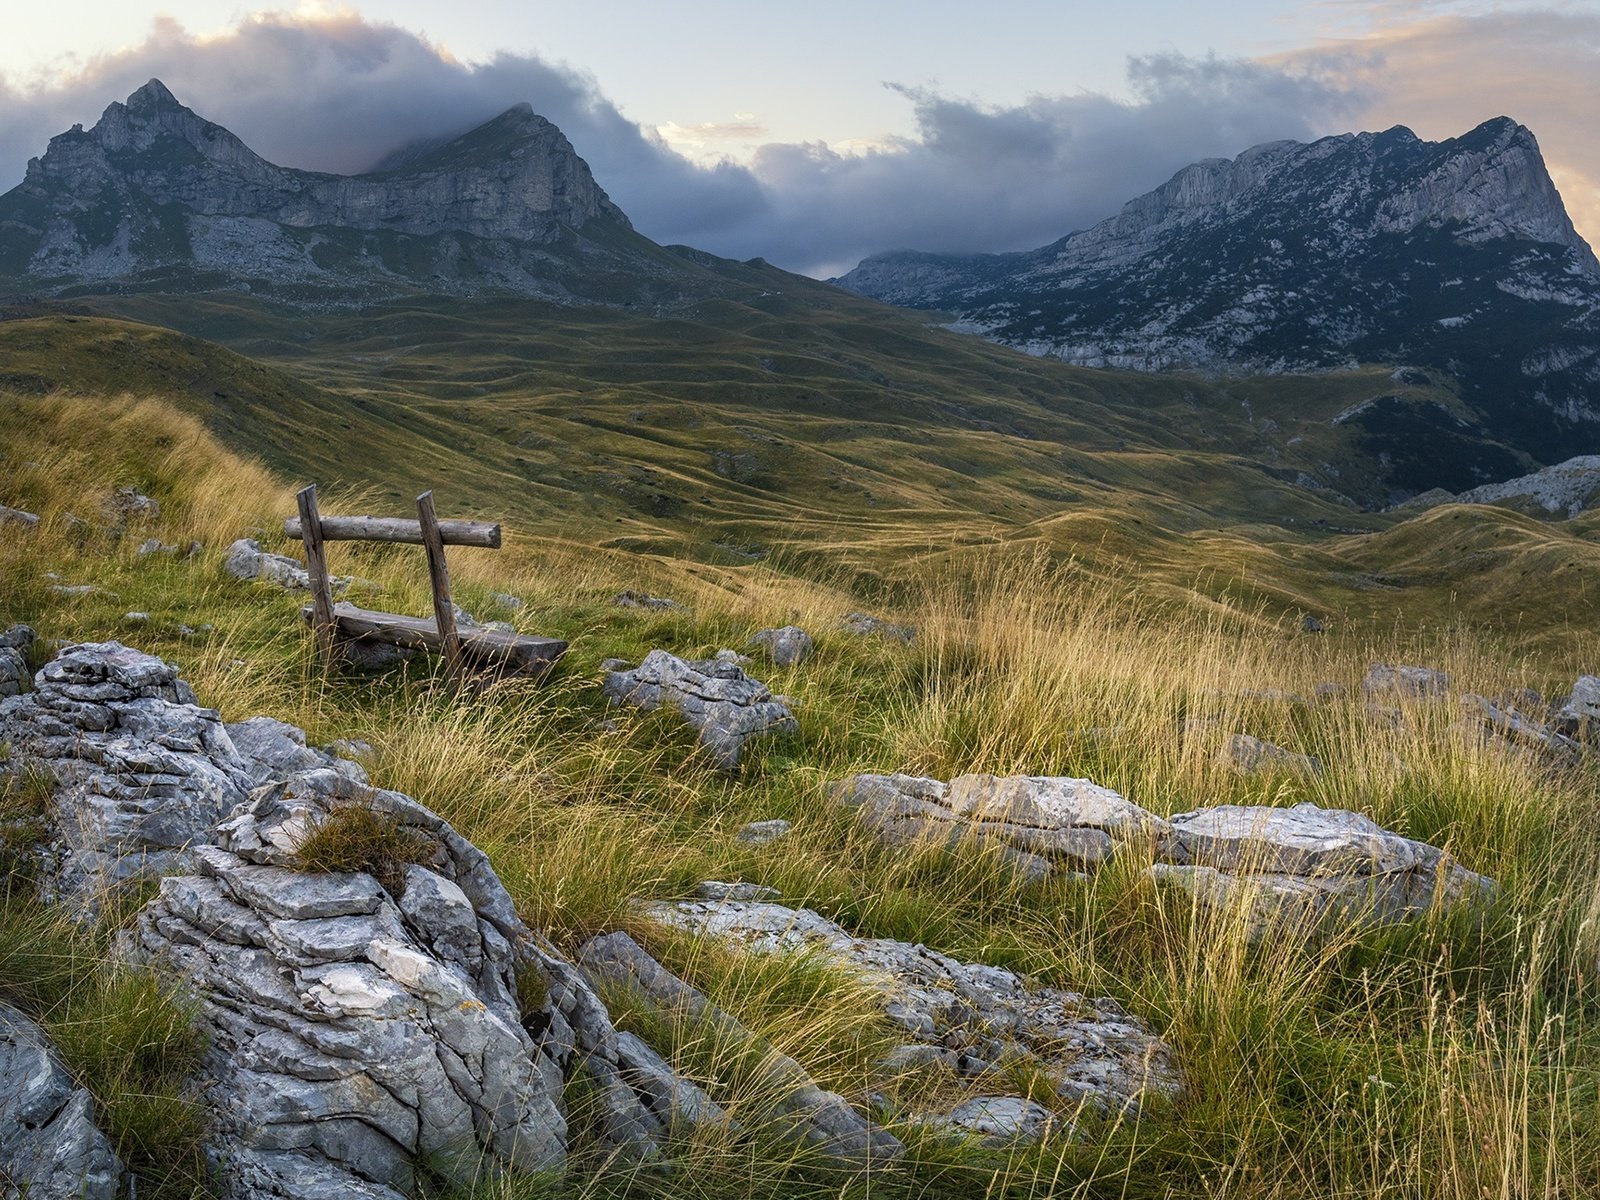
[578,933,906,1170]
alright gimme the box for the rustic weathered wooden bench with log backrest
[283,485,566,683]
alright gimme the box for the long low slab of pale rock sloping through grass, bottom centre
[642,901,1179,1112]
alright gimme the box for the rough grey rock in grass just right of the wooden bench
[605,650,800,770]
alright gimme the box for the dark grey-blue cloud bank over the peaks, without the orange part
[0,14,1355,274]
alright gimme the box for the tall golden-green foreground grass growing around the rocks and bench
[0,397,1600,1200]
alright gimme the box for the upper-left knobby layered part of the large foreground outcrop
[0,642,254,902]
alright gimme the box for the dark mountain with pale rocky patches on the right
[837,117,1600,491]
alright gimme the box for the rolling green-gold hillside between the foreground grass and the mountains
[0,294,1600,658]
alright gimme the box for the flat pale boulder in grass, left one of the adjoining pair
[834,774,1170,882]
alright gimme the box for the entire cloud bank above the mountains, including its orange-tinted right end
[21,3,1600,275]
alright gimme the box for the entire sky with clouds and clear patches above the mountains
[0,0,1600,277]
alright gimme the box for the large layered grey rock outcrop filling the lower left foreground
[0,643,718,1200]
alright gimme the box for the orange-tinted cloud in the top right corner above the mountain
[1278,5,1600,254]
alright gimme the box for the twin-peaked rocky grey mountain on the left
[0,80,704,302]
